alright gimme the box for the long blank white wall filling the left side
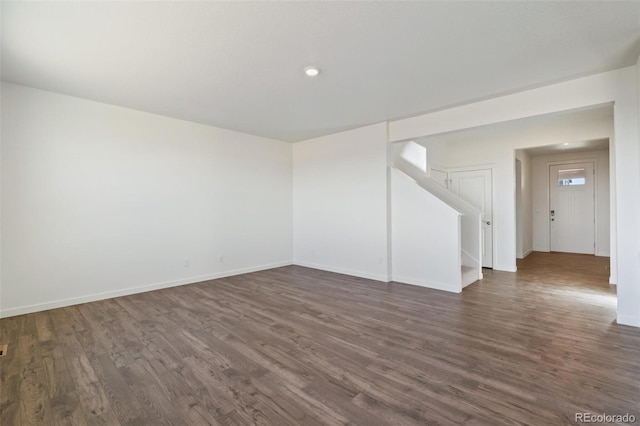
[0,83,292,316]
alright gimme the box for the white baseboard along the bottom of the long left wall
[0,261,292,318]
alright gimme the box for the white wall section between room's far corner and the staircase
[293,123,389,281]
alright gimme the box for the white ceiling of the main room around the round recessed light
[1,1,640,142]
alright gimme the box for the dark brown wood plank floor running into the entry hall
[0,253,640,426]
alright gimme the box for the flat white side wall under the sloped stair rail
[391,169,462,293]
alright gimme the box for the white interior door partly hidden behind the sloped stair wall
[449,169,493,268]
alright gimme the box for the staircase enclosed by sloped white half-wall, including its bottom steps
[392,142,482,293]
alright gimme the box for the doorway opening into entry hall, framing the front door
[515,138,612,286]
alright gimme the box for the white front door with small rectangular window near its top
[549,163,595,254]
